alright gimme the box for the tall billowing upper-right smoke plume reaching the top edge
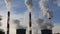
[39,0,52,18]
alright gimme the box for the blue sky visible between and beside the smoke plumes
[0,0,60,31]
